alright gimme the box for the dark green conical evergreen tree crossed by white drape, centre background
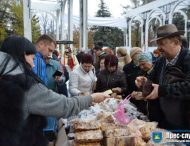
[91,0,124,49]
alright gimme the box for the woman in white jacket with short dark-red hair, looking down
[69,53,97,96]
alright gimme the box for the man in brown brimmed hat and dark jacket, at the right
[135,24,190,130]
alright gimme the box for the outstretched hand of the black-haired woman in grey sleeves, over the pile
[91,93,110,103]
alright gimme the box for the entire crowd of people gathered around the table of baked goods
[0,24,190,146]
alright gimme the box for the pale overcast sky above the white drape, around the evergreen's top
[73,0,130,17]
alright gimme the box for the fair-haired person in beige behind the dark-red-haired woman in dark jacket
[116,48,131,71]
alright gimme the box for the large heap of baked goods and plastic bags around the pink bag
[67,98,160,146]
